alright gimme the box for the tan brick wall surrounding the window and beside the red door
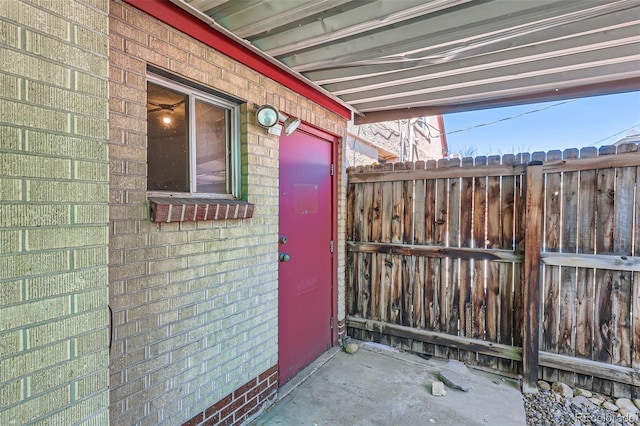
[109,1,345,425]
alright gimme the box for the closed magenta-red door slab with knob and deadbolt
[278,131,333,384]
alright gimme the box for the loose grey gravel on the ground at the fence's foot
[524,389,640,426]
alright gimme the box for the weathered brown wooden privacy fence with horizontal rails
[347,144,640,397]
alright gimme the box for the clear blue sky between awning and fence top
[443,92,640,157]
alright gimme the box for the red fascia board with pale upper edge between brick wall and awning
[124,0,356,120]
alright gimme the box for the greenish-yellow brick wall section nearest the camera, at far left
[0,0,109,425]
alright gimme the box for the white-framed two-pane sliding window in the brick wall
[147,75,240,198]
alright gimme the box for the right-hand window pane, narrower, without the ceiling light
[195,99,229,194]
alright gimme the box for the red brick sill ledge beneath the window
[149,197,254,223]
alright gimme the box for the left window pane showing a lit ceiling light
[147,83,189,192]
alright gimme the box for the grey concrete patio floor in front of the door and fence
[249,343,526,426]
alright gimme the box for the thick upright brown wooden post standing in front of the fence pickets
[522,161,544,393]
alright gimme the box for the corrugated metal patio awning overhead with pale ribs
[171,0,640,122]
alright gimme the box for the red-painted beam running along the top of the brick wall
[124,0,351,120]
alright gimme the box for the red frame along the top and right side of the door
[278,121,342,346]
